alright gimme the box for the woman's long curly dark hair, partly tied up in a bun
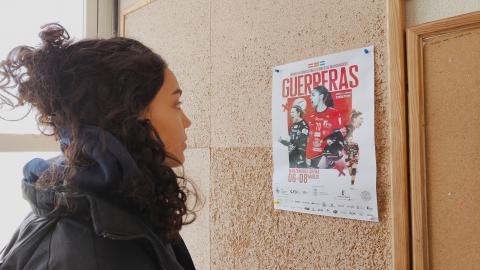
[0,24,197,239]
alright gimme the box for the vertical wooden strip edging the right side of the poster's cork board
[387,0,411,270]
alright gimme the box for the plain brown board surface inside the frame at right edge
[424,27,480,269]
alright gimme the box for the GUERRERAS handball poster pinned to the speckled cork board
[272,46,378,222]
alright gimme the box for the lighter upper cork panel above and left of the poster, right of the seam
[210,0,387,147]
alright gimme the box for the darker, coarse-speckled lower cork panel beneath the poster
[210,147,392,270]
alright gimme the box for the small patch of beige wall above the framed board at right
[405,0,480,27]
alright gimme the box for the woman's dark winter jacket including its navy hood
[0,125,195,270]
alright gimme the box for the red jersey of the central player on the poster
[305,107,344,159]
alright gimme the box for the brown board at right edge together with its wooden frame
[407,12,480,270]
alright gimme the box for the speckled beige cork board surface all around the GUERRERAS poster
[126,0,392,270]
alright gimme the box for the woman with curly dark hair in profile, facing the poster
[0,24,197,270]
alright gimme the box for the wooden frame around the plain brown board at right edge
[407,12,480,270]
